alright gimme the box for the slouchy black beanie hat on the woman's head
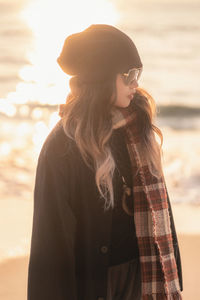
[57,24,142,82]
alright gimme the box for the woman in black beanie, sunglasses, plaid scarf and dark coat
[28,24,183,300]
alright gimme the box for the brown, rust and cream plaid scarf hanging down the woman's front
[113,100,182,300]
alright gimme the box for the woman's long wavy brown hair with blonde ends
[60,76,163,209]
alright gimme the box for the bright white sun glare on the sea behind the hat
[0,0,118,117]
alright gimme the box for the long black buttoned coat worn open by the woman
[28,122,182,300]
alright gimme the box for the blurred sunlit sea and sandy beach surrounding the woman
[0,0,200,300]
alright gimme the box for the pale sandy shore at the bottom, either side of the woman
[0,200,200,300]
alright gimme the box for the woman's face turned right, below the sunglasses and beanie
[114,74,138,107]
